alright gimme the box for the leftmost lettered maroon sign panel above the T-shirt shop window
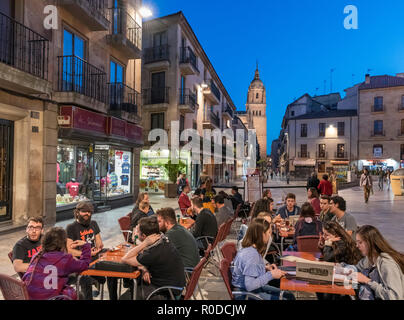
[60,106,107,134]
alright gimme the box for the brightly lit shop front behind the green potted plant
[140,150,192,194]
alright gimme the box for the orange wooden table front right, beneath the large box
[280,252,355,296]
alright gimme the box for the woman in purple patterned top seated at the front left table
[22,227,91,300]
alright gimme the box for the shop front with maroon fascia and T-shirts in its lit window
[56,106,142,220]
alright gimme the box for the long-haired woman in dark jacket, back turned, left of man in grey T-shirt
[289,202,323,251]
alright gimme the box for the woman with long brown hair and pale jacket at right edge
[356,225,404,300]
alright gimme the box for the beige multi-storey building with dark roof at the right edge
[358,74,404,170]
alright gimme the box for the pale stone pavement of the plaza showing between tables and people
[0,181,404,300]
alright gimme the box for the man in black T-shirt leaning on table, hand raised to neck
[122,216,185,299]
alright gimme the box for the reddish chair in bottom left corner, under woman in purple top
[0,274,72,300]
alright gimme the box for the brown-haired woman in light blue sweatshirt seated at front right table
[232,219,295,300]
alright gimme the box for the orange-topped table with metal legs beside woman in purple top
[76,244,140,300]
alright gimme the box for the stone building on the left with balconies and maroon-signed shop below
[0,0,142,228]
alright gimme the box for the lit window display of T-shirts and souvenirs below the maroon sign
[56,144,132,206]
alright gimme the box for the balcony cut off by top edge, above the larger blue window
[56,0,110,31]
